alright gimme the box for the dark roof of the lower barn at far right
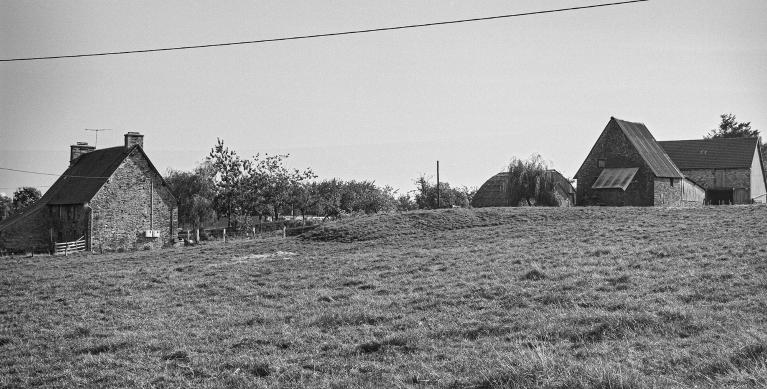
[658,138,759,170]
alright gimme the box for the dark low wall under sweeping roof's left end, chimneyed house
[0,207,52,253]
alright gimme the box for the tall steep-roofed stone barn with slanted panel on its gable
[575,118,705,206]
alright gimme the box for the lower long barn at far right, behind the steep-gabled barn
[658,138,767,204]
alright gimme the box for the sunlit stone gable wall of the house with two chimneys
[90,150,178,251]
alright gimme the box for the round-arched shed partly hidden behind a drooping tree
[471,170,575,208]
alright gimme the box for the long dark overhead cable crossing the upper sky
[0,0,650,62]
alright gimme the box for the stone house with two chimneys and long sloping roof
[0,132,178,252]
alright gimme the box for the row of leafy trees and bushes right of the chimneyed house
[164,139,475,228]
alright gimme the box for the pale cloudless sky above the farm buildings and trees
[0,0,767,194]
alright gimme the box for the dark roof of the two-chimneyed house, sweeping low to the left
[0,145,175,230]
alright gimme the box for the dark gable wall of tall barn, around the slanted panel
[576,124,655,206]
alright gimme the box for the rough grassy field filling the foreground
[0,206,767,388]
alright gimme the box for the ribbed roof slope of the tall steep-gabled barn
[610,118,684,178]
